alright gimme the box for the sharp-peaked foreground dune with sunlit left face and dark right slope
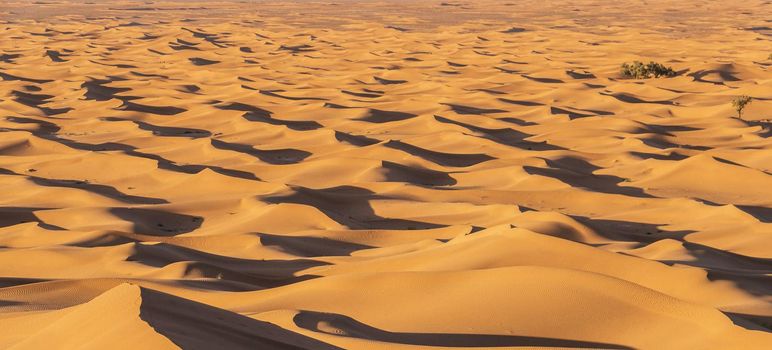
[3,283,340,349]
